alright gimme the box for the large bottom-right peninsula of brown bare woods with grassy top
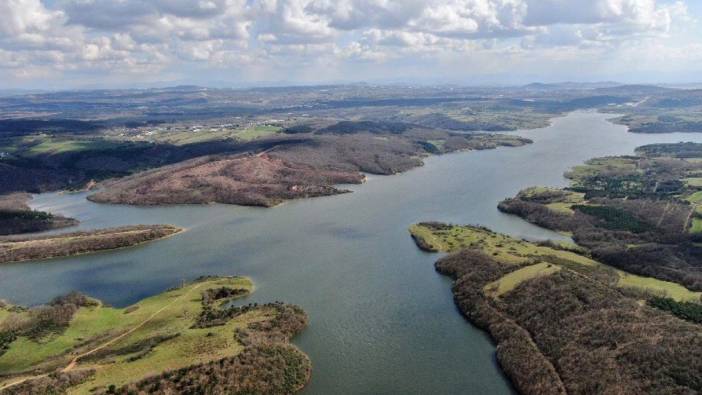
[411,223,702,395]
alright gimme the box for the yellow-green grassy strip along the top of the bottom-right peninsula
[410,224,702,301]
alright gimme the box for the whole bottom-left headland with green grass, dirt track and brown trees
[0,277,311,394]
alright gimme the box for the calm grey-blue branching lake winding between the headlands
[0,112,702,394]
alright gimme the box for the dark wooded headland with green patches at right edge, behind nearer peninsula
[498,143,702,290]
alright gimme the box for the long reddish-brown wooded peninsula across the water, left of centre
[89,131,530,207]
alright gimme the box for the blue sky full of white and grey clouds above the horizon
[0,0,702,89]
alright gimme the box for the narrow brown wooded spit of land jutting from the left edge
[0,225,183,264]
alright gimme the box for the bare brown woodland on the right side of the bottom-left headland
[108,302,311,395]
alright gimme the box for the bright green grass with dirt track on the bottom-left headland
[0,277,310,394]
